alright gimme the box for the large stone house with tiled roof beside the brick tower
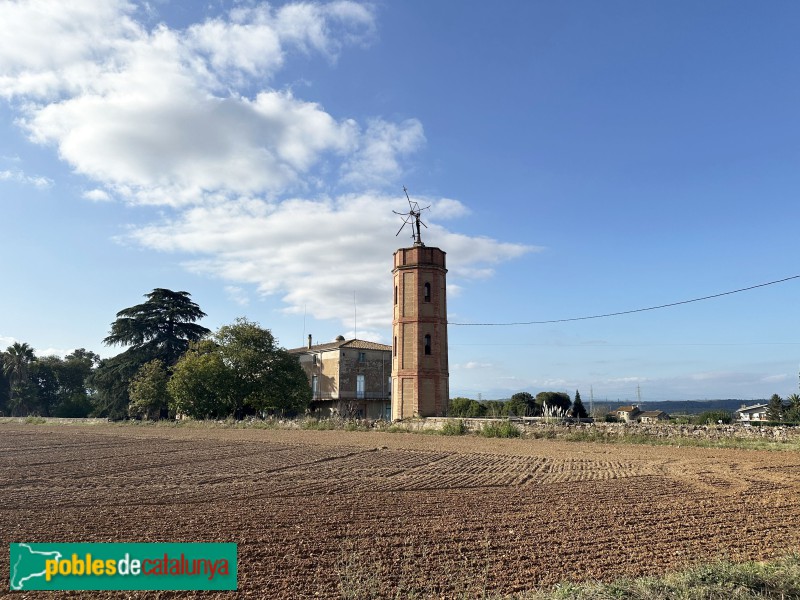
[289,335,392,420]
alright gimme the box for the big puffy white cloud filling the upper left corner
[0,0,376,205]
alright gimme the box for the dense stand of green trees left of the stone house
[0,288,311,419]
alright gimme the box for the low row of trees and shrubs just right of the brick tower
[447,390,589,419]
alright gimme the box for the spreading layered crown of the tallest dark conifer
[103,288,211,366]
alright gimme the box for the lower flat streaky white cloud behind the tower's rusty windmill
[130,194,530,329]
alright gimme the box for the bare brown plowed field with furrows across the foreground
[0,423,800,598]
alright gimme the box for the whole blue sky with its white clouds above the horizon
[0,0,800,402]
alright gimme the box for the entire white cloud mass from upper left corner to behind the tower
[0,0,535,335]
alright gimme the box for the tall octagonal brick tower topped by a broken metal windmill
[392,188,450,419]
